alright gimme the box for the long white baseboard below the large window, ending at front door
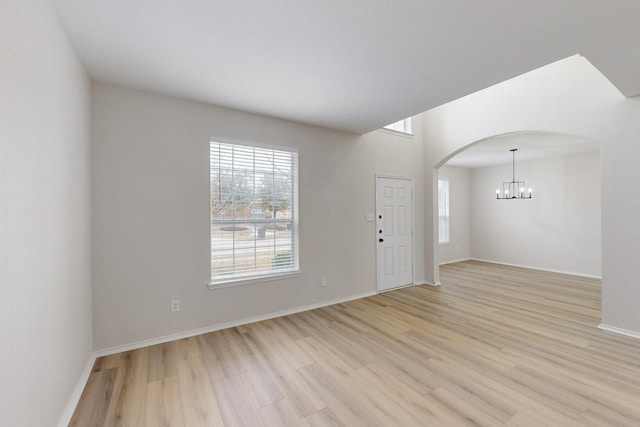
[94,291,376,357]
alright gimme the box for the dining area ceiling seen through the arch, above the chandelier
[447,132,600,168]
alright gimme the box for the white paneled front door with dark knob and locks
[376,177,413,292]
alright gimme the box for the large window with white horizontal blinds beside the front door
[209,141,299,285]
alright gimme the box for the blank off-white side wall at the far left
[0,0,93,426]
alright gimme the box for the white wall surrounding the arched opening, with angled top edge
[423,56,640,333]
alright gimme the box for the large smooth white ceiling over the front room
[53,0,640,134]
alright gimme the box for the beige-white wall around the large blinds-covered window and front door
[92,83,424,349]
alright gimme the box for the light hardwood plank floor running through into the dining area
[71,262,640,427]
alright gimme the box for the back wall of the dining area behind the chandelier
[471,151,601,277]
